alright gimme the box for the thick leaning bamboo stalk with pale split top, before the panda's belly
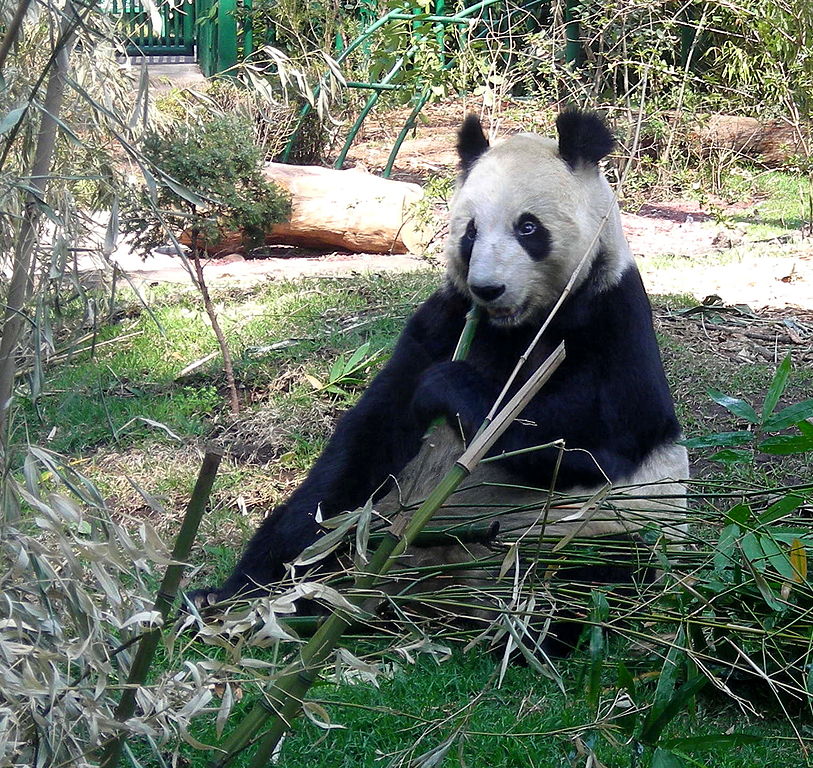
[210,344,565,768]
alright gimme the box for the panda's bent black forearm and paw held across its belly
[416,361,680,486]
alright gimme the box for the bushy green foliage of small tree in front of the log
[123,116,290,252]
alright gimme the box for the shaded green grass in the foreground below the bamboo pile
[162,649,799,768]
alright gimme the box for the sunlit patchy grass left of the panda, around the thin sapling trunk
[11,274,432,454]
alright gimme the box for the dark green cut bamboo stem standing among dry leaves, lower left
[99,448,223,768]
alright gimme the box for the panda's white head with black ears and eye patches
[446,110,631,327]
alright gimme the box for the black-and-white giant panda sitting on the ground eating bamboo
[193,109,688,640]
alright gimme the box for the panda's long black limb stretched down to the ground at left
[203,288,468,600]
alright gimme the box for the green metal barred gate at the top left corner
[110,0,195,56]
